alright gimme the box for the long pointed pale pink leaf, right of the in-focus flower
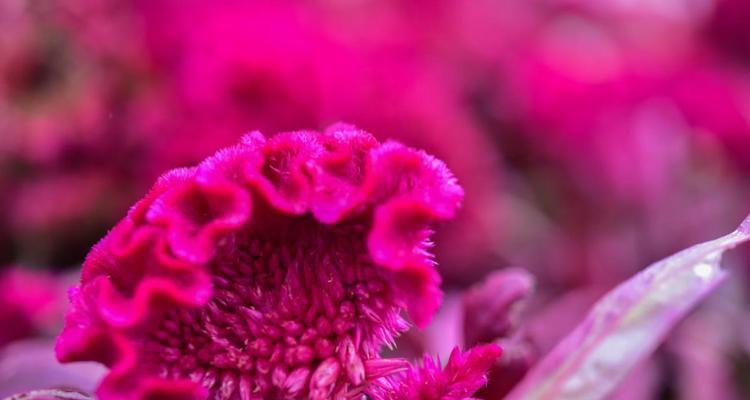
[506,217,750,400]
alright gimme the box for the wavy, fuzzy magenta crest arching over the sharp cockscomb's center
[56,124,463,399]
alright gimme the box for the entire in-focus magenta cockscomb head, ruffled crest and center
[57,125,463,400]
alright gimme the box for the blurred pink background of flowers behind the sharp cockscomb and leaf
[0,0,750,399]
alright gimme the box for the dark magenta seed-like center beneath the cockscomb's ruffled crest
[146,221,406,400]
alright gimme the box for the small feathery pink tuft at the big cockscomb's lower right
[370,344,501,400]
